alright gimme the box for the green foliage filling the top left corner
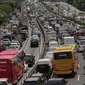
[0,0,23,24]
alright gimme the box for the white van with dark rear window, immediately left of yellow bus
[36,58,53,80]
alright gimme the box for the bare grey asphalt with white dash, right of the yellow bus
[67,53,85,85]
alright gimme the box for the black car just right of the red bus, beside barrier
[24,54,35,67]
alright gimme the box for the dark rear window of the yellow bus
[54,52,72,60]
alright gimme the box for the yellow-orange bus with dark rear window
[53,44,78,75]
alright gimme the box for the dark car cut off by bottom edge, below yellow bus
[46,78,67,85]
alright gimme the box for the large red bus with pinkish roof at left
[0,50,25,84]
